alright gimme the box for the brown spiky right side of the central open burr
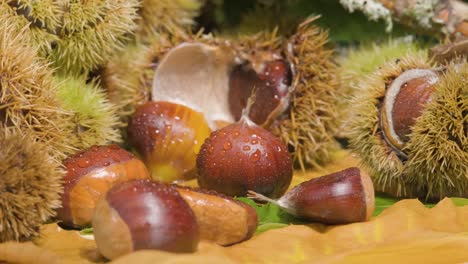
[274,18,341,169]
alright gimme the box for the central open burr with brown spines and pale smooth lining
[135,19,340,168]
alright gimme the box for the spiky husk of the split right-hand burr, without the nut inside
[350,53,468,199]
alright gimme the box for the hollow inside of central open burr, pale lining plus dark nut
[152,43,292,130]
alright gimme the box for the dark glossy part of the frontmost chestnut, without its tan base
[106,180,199,252]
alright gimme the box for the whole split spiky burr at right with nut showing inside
[350,56,467,199]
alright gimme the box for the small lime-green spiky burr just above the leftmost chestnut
[56,77,121,153]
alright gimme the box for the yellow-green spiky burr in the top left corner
[0,0,140,75]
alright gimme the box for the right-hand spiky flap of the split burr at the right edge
[404,61,468,198]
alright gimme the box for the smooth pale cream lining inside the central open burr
[152,43,235,129]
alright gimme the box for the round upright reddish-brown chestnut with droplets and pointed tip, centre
[197,117,293,197]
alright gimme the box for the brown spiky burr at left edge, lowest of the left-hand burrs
[0,127,64,242]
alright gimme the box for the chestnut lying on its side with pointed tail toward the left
[249,167,375,224]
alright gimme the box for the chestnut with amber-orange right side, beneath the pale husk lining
[128,102,211,182]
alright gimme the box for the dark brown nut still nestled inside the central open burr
[229,60,292,124]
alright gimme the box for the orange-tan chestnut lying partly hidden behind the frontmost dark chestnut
[175,186,258,246]
